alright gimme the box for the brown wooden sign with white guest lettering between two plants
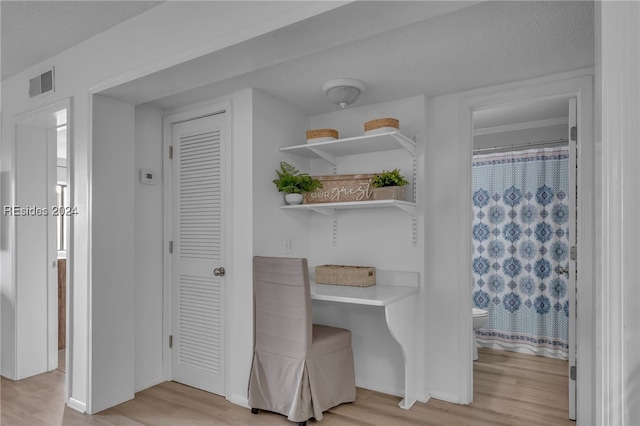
[304,174,375,204]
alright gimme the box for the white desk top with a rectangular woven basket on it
[311,282,418,306]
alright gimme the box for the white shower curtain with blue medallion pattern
[473,147,573,359]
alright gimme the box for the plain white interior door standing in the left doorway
[15,119,58,379]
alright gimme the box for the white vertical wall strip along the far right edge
[592,1,640,426]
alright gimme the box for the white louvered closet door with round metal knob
[172,114,226,395]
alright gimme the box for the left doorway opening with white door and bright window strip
[12,99,71,390]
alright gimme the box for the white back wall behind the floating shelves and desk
[308,96,430,400]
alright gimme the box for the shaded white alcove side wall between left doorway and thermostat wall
[88,95,135,413]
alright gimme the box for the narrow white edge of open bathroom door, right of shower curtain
[568,98,578,420]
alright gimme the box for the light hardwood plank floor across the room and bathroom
[0,349,575,426]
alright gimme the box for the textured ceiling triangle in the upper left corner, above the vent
[0,0,163,80]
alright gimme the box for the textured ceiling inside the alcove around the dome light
[134,1,595,115]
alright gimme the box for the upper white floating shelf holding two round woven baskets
[280,132,416,165]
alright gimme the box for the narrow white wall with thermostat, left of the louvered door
[133,106,165,392]
